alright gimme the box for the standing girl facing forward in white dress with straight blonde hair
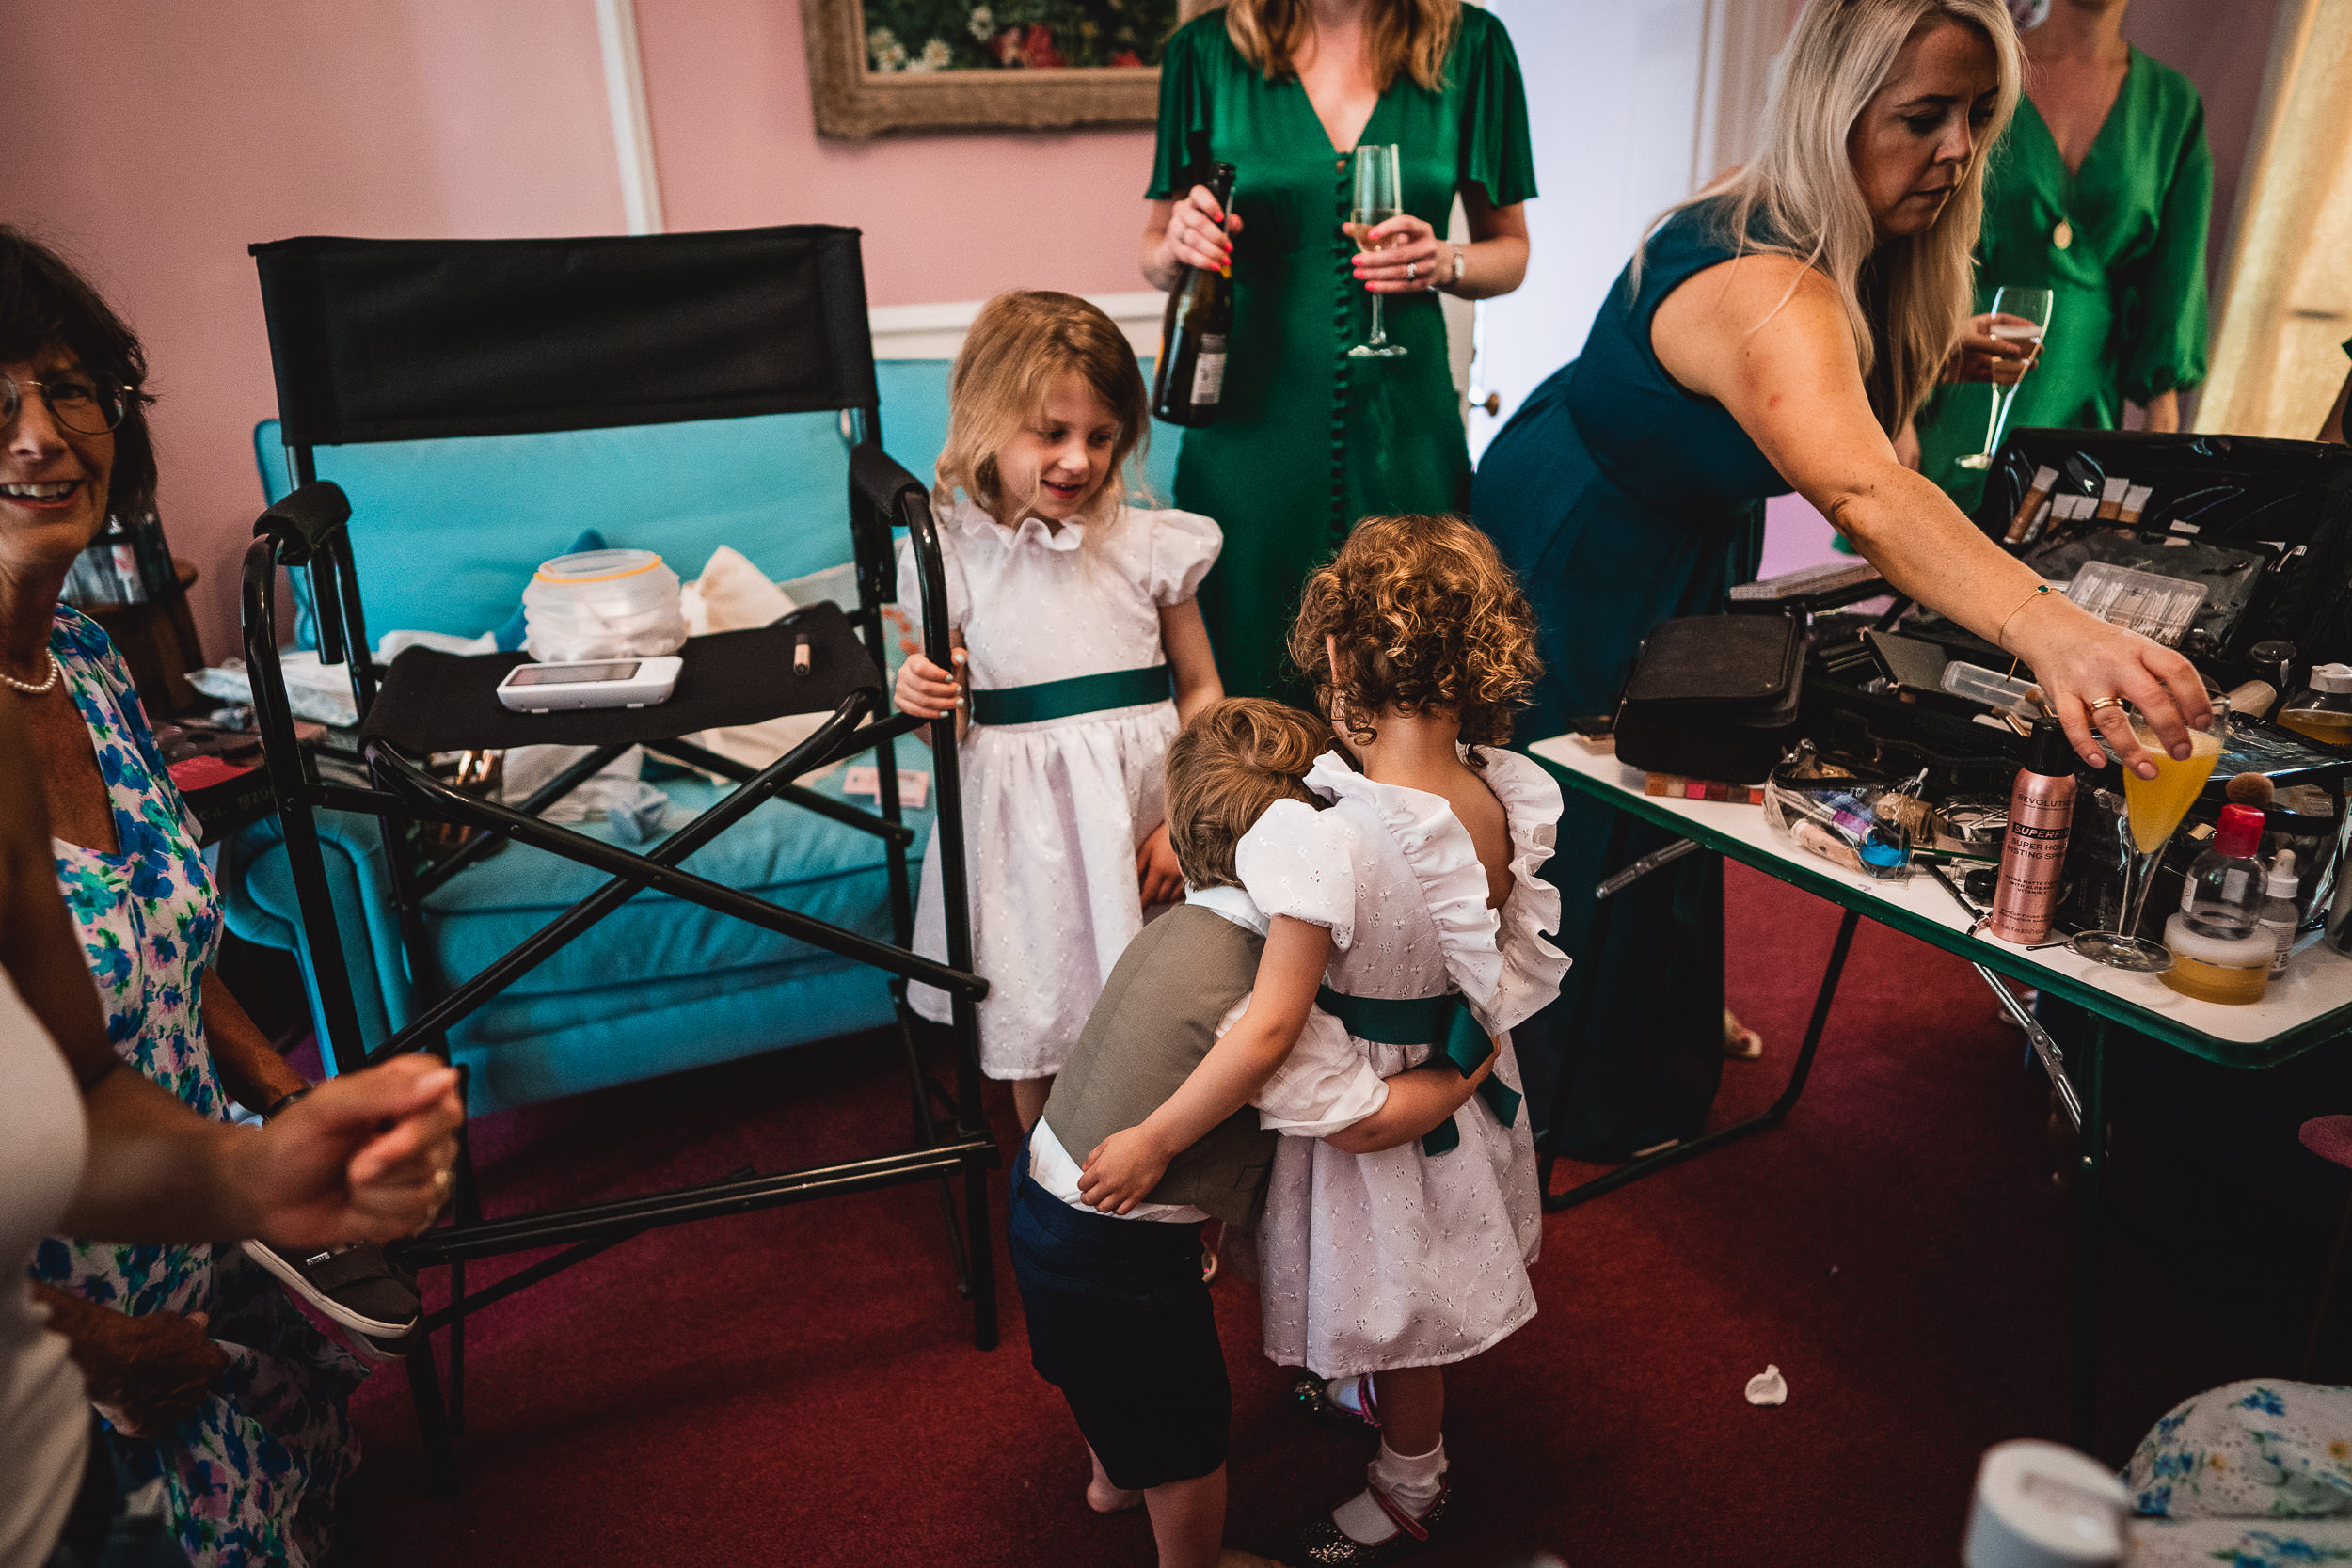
[897,292,1223,1131]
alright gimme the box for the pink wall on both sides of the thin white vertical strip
[0,0,1151,658]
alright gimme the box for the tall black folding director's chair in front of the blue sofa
[245,226,997,1496]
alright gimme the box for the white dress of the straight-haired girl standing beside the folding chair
[898,500,1223,1079]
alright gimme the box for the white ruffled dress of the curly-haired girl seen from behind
[1235,750,1569,1378]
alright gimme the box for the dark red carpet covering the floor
[326,867,2343,1568]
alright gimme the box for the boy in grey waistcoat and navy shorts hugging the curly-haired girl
[1007,698,1485,1568]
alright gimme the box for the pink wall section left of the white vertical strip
[0,0,621,658]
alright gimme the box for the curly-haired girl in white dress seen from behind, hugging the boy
[1235,517,1569,1563]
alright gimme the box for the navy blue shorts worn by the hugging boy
[1005,1149,1232,1491]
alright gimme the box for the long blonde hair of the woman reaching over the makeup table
[1635,0,2023,435]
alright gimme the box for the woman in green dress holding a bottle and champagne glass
[1143,0,1536,696]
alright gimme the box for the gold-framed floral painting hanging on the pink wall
[800,0,1204,138]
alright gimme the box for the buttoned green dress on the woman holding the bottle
[1148,7,1536,696]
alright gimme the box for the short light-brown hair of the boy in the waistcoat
[1167,696,1327,889]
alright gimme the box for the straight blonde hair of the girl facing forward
[931,289,1151,533]
